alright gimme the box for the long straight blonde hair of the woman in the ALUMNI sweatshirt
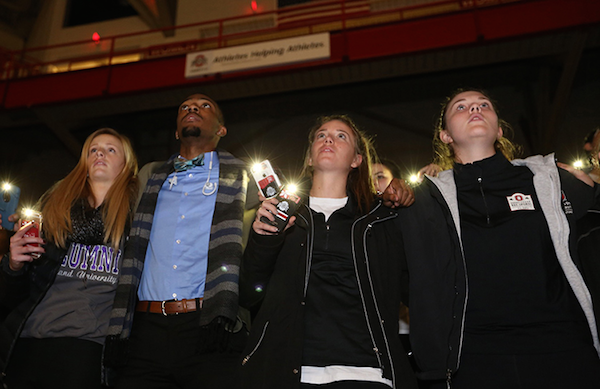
[41,128,138,248]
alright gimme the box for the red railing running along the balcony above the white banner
[0,0,532,80]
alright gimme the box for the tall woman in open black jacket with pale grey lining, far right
[384,89,600,389]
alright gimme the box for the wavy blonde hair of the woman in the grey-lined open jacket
[433,88,521,170]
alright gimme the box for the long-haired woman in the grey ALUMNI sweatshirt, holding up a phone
[0,128,137,389]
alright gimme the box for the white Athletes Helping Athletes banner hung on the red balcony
[185,32,331,78]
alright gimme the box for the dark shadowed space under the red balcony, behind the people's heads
[0,0,600,208]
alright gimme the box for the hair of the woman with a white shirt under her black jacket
[302,115,376,214]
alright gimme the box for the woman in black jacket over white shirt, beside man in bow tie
[240,116,416,389]
